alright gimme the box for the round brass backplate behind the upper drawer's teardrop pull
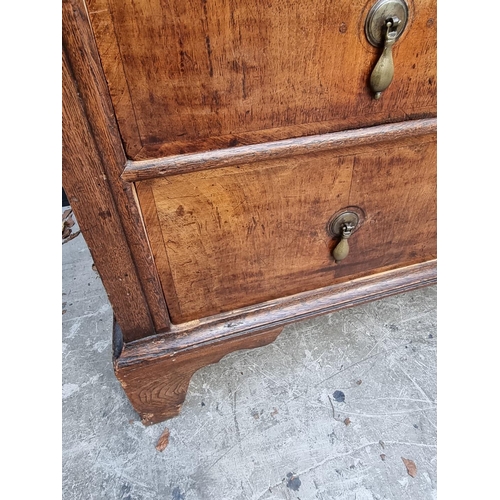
[365,0,408,47]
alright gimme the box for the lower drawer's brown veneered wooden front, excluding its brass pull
[136,135,436,323]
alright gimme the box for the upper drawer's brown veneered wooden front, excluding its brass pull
[87,0,436,160]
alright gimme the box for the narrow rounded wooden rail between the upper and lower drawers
[122,118,437,182]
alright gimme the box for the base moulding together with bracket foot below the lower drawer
[115,261,436,425]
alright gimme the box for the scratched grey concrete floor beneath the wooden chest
[62,211,437,500]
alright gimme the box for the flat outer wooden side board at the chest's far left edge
[62,47,154,340]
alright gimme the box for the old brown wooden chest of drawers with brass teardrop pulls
[63,0,436,424]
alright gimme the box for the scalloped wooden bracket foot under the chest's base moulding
[115,327,283,425]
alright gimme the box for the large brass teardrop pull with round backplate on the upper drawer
[365,0,408,99]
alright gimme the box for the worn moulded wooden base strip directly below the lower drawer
[119,260,437,367]
